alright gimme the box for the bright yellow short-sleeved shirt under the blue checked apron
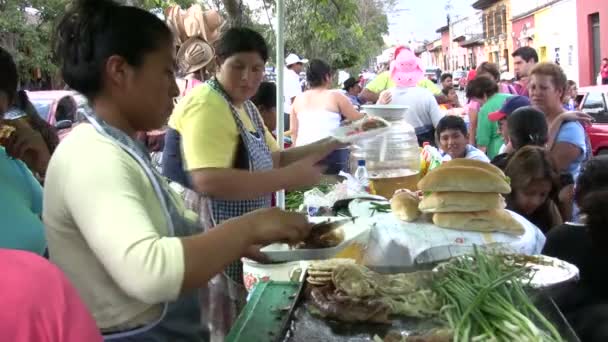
[169,84,280,171]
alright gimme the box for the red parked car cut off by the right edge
[576,85,608,155]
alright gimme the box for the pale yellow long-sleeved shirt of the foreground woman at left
[43,124,190,330]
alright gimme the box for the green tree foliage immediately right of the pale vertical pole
[254,0,395,72]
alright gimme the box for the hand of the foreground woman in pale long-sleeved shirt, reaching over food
[243,208,312,247]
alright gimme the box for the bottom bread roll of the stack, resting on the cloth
[433,209,525,235]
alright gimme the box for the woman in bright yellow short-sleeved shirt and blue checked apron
[163,28,340,336]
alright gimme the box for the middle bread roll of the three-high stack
[418,192,506,213]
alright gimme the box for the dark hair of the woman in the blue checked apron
[215,27,268,63]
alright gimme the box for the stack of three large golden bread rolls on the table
[418,158,524,235]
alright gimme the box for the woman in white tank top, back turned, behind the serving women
[290,59,363,174]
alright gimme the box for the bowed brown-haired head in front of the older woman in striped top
[505,146,559,215]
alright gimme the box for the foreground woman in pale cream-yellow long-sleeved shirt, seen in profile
[43,0,310,341]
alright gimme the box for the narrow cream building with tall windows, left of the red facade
[473,0,513,71]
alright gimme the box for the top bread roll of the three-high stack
[418,166,511,194]
